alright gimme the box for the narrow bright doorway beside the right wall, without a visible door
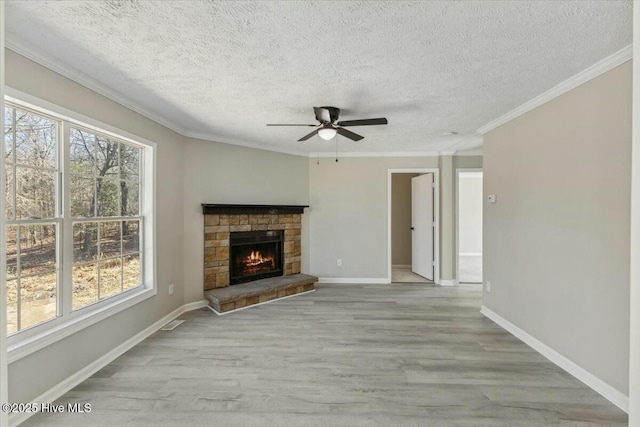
[456,169,483,284]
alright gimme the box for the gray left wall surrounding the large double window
[5,50,184,402]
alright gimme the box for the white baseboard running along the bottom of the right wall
[480,305,629,413]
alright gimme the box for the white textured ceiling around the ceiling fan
[6,0,632,153]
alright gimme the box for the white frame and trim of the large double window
[2,87,158,363]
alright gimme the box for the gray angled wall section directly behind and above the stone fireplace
[179,138,309,302]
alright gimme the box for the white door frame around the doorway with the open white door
[387,168,440,285]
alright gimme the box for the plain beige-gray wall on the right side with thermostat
[483,61,632,394]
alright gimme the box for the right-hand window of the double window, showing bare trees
[70,128,142,309]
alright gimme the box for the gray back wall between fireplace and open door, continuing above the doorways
[308,156,482,279]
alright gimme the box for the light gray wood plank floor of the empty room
[23,284,627,427]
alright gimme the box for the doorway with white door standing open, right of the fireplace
[387,169,440,283]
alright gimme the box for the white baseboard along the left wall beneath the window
[9,300,208,427]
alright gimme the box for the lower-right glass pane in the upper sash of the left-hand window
[16,167,56,219]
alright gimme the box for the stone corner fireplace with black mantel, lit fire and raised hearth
[202,204,318,314]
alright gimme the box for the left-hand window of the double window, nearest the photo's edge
[4,107,60,334]
